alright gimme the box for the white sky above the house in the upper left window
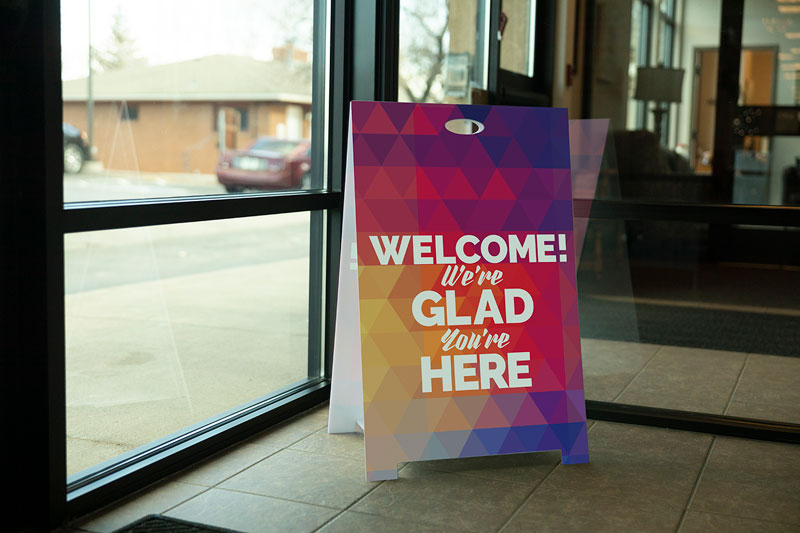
[61,0,313,80]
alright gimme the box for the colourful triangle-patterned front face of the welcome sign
[346,102,588,480]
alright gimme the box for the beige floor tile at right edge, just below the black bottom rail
[692,437,800,525]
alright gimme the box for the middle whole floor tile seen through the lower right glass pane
[617,346,746,414]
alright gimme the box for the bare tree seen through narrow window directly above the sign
[399,0,450,102]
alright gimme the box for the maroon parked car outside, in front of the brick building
[217,137,311,192]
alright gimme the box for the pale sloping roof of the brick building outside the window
[62,55,311,104]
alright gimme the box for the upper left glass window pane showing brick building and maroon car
[61,0,314,202]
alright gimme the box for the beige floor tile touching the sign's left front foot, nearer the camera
[220,449,375,509]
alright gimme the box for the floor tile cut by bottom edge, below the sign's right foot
[502,489,683,533]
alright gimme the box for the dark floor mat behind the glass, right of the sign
[579,298,800,357]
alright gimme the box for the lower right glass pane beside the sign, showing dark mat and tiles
[578,216,800,423]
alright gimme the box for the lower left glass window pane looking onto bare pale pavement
[64,212,319,474]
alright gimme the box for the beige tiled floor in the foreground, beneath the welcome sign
[65,404,800,533]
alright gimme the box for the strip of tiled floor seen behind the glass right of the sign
[581,338,800,424]
